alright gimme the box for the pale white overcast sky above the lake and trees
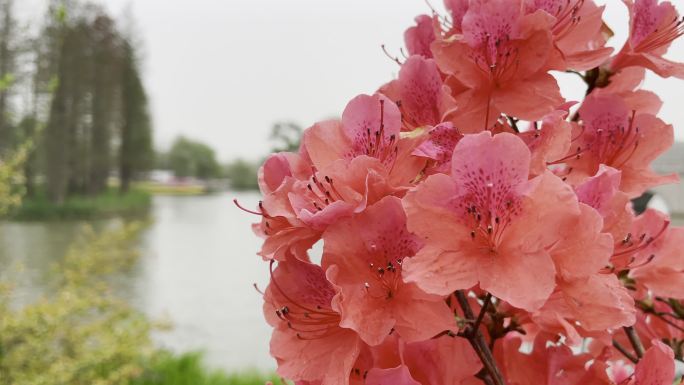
[17,0,684,161]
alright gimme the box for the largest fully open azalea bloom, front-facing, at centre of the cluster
[404,132,584,310]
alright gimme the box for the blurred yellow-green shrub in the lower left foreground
[0,218,274,385]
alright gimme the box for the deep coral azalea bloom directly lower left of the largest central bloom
[322,197,456,345]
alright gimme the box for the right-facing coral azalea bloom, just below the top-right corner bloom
[566,94,678,198]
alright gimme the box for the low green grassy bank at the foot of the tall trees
[9,188,152,220]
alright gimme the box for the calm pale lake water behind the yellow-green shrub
[0,193,275,370]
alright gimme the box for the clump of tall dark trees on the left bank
[0,0,154,203]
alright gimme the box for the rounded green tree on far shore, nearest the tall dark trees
[168,136,220,179]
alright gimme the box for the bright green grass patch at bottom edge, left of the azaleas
[131,353,281,385]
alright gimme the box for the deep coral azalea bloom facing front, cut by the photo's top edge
[433,0,563,132]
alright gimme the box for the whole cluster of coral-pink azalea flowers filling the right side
[247,0,684,385]
